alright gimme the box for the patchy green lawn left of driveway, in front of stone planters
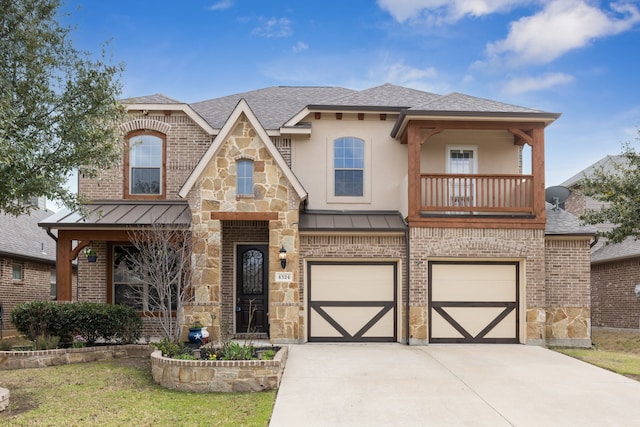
[0,359,275,426]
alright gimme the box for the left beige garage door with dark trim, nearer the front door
[307,262,397,342]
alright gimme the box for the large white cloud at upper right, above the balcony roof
[486,0,640,65]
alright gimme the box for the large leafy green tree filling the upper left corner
[0,0,124,215]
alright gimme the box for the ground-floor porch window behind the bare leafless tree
[112,246,177,311]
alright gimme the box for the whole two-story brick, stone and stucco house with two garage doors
[41,84,593,345]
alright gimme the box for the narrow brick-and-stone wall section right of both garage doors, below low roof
[545,239,591,345]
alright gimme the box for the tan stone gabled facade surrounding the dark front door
[180,115,300,343]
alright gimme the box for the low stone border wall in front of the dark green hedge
[0,344,152,370]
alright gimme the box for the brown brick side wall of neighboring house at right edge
[591,258,640,329]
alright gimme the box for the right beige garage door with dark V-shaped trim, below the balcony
[429,261,519,343]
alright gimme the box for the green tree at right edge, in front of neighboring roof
[580,133,640,243]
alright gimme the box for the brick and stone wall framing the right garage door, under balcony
[409,228,545,344]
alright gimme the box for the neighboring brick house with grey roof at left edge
[0,203,75,336]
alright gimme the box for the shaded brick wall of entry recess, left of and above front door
[220,221,269,336]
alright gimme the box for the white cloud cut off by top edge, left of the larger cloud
[378,0,532,23]
